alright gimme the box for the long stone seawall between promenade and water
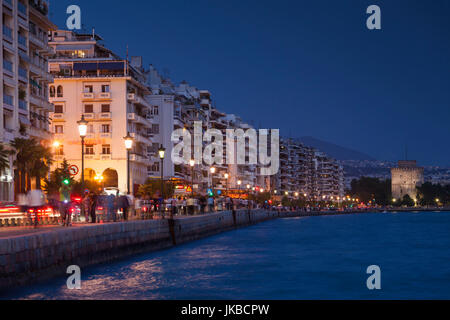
[0,210,284,292]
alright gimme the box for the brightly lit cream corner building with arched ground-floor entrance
[49,30,155,193]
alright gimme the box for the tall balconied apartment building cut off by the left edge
[0,0,56,201]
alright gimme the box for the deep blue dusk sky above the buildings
[47,0,450,166]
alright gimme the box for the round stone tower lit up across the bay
[391,160,424,200]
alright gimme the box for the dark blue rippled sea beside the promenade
[2,212,450,300]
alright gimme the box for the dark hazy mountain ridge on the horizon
[299,137,376,161]
